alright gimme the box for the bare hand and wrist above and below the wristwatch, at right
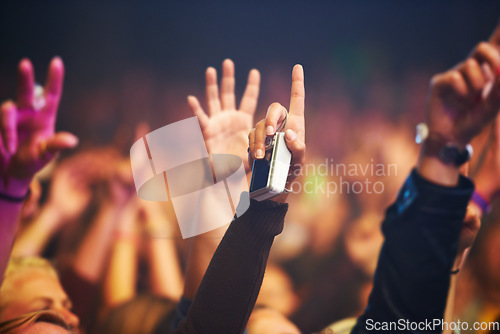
[419,25,500,186]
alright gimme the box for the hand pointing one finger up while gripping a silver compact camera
[248,65,306,202]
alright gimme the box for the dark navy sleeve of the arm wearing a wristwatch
[352,170,474,333]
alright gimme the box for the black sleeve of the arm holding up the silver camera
[156,200,288,334]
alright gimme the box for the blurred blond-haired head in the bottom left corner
[0,268,79,333]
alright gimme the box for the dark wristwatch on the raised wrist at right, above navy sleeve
[415,123,472,167]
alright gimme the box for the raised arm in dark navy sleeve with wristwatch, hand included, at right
[353,22,500,333]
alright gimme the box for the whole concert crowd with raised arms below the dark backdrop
[0,20,500,334]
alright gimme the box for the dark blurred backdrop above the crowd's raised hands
[0,1,500,143]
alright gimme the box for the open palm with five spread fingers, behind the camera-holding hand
[188,59,260,171]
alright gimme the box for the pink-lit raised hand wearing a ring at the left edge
[0,57,78,196]
